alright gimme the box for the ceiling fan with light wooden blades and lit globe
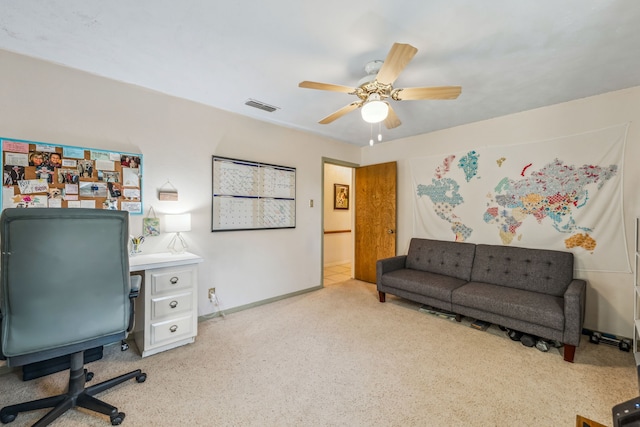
[298,43,462,129]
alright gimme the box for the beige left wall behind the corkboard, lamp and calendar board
[0,50,360,315]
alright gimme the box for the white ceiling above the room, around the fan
[0,0,640,145]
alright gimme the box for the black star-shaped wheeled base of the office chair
[0,351,147,427]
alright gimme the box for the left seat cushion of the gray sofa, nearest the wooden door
[382,268,467,302]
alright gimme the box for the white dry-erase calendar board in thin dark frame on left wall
[211,156,296,231]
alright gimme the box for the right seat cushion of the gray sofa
[451,282,564,330]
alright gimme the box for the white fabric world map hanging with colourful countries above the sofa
[411,124,631,272]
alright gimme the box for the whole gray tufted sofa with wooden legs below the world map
[376,238,586,362]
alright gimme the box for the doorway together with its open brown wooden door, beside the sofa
[322,159,397,286]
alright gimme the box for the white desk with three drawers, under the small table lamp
[129,252,203,357]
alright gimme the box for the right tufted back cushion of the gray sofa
[471,245,573,296]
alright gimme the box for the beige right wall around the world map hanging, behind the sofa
[362,87,640,337]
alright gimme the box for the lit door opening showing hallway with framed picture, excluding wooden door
[323,160,356,286]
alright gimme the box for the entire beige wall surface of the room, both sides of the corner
[0,46,640,336]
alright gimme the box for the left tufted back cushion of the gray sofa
[406,238,476,280]
